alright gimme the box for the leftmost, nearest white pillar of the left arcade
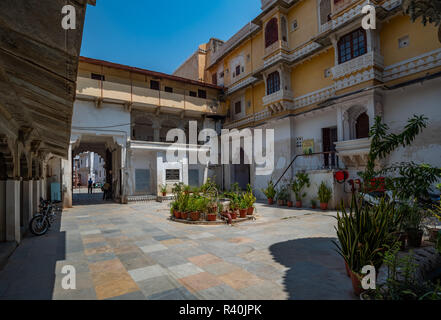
[6,180,21,243]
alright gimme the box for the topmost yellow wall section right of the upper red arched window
[288,0,318,49]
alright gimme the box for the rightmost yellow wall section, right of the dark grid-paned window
[380,16,441,66]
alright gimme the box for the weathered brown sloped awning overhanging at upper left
[0,0,95,158]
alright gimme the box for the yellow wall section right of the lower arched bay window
[291,48,334,97]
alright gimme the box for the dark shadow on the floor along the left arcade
[0,217,66,300]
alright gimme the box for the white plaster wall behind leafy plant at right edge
[384,79,441,167]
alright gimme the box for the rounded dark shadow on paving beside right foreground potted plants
[269,238,356,300]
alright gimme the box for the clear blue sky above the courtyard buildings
[81,0,260,73]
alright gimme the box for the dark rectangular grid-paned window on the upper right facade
[338,28,367,63]
